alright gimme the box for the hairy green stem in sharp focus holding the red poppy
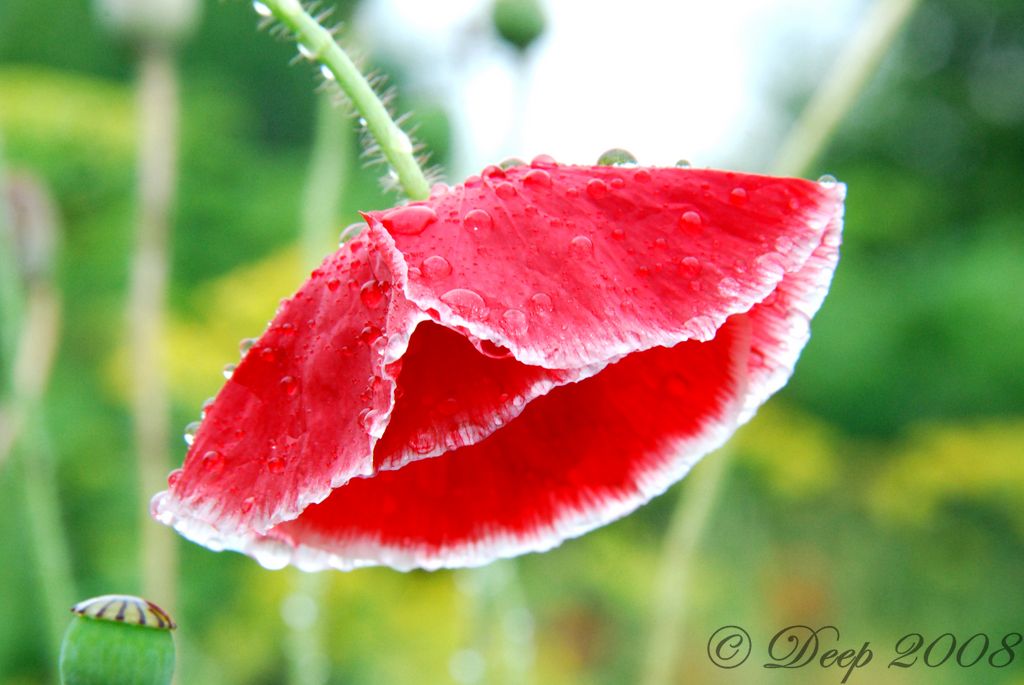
[262,0,430,200]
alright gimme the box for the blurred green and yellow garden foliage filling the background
[0,0,1024,685]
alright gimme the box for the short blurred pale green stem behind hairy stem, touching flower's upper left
[299,91,352,269]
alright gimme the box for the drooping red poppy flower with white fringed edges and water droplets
[153,158,845,569]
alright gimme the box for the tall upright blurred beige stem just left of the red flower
[128,42,178,614]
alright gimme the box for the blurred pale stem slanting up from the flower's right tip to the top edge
[772,0,919,176]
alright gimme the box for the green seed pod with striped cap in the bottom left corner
[60,595,176,685]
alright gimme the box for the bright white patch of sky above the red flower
[356,0,863,180]
